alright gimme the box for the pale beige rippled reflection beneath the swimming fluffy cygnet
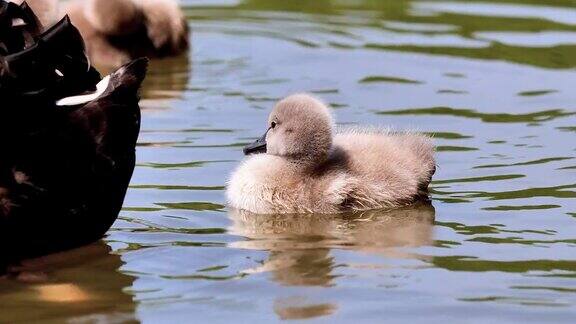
[229,202,435,319]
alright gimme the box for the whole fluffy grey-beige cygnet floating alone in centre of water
[226,94,436,214]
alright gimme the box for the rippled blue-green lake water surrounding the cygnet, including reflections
[0,0,576,323]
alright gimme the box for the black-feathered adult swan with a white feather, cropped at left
[0,0,147,264]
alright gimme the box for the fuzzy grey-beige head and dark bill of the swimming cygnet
[244,94,334,165]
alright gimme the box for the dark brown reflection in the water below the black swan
[0,241,136,323]
